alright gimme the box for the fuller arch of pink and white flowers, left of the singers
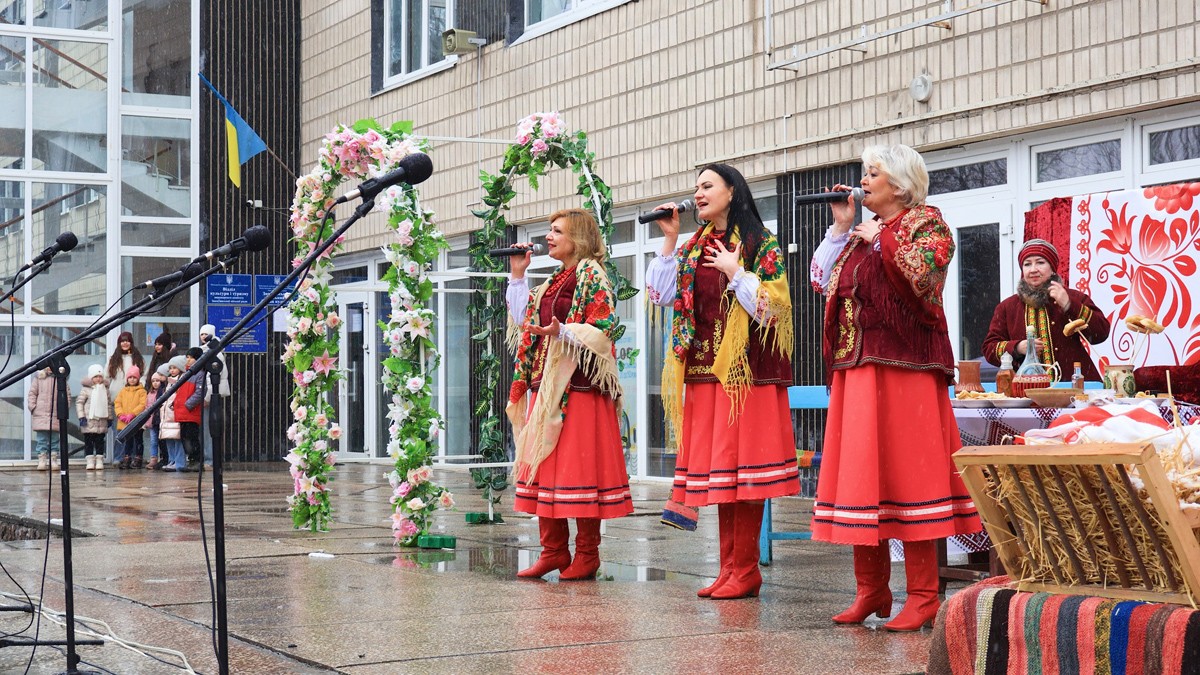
[282,120,454,545]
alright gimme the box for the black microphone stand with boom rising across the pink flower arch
[116,198,374,675]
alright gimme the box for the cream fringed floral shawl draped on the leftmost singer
[505,259,622,483]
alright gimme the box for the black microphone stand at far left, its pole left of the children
[0,256,236,675]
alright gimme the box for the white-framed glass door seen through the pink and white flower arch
[334,292,378,459]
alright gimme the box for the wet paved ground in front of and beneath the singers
[0,462,930,675]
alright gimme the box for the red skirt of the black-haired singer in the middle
[671,382,800,506]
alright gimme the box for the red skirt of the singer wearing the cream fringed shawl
[512,392,634,519]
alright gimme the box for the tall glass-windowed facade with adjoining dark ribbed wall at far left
[0,0,300,460]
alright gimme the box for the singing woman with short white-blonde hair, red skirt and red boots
[810,145,982,631]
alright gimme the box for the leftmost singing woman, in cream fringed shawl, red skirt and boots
[506,209,634,581]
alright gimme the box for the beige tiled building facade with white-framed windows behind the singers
[300,0,1200,477]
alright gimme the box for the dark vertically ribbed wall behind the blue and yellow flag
[200,0,301,461]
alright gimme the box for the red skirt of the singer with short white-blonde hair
[812,364,983,545]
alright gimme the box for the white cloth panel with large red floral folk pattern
[1070,183,1200,366]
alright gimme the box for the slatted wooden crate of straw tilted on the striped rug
[954,443,1200,607]
